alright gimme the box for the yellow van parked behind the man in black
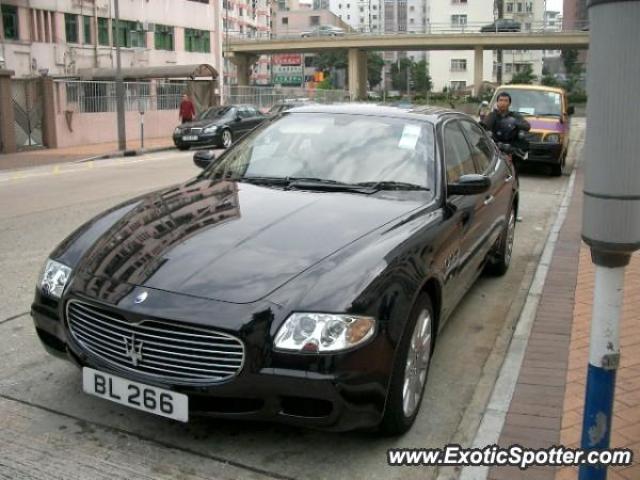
[490,85,574,176]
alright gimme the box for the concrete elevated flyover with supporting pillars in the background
[225,30,589,99]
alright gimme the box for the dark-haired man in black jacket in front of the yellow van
[480,92,531,153]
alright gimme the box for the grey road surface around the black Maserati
[0,119,584,480]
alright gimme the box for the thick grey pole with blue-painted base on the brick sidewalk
[579,0,640,480]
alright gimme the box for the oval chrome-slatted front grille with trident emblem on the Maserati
[67,300,244,385]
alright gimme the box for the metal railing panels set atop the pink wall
[56,80,187,113]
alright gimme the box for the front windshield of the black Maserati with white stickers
[204,113,434,189]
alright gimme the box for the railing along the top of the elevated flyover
[223,19,589,43]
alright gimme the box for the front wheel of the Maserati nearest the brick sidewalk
[379,293,435,435]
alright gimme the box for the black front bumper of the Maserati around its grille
[31,286,393,431]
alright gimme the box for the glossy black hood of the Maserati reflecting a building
[78,179,424,303]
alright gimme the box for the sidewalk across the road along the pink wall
[0,137,174,170]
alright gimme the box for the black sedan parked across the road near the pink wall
[173,105,267,150]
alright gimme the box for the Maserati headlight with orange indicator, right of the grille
[275,313,375,353]
